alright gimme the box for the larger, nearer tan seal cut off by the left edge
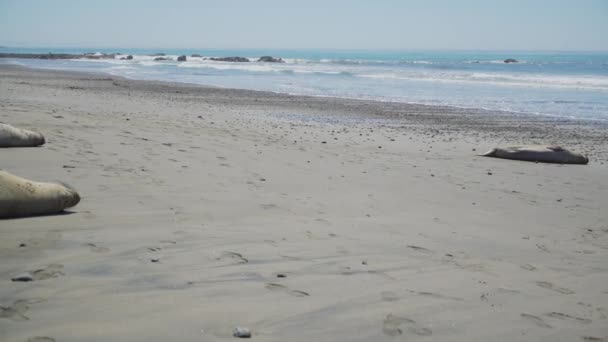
[0,170,80,217]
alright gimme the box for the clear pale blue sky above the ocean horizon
[0,0,608,51]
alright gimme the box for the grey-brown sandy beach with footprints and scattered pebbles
[0,65,608,342]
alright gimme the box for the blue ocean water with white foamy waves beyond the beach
[0,48,608,121]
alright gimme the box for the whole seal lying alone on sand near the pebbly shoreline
[482,145,589,164]
